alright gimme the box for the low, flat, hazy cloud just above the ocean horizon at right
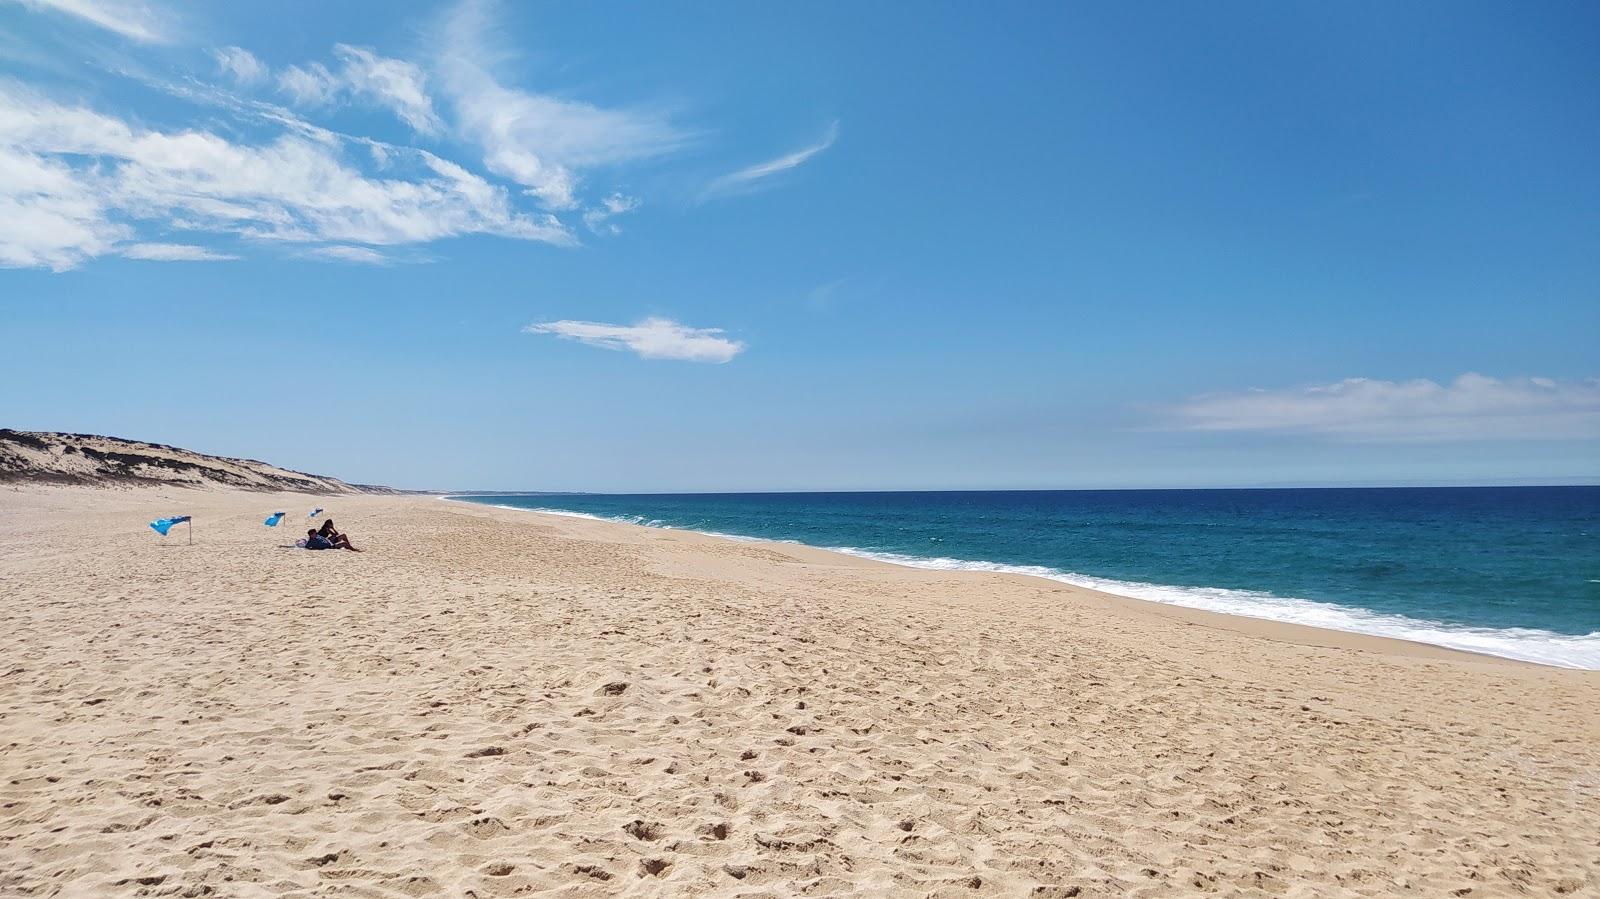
[1174,374,1600,442]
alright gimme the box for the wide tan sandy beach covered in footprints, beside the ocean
[0,488,1600,897]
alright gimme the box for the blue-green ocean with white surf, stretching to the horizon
[454,486,1600,669]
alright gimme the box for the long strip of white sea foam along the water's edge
[448,504,1600,670]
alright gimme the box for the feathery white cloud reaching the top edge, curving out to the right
[438,0,685,210]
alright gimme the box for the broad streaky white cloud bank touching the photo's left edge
[0,82,573,269]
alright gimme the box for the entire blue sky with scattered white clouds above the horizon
[0,0,1600,491]
